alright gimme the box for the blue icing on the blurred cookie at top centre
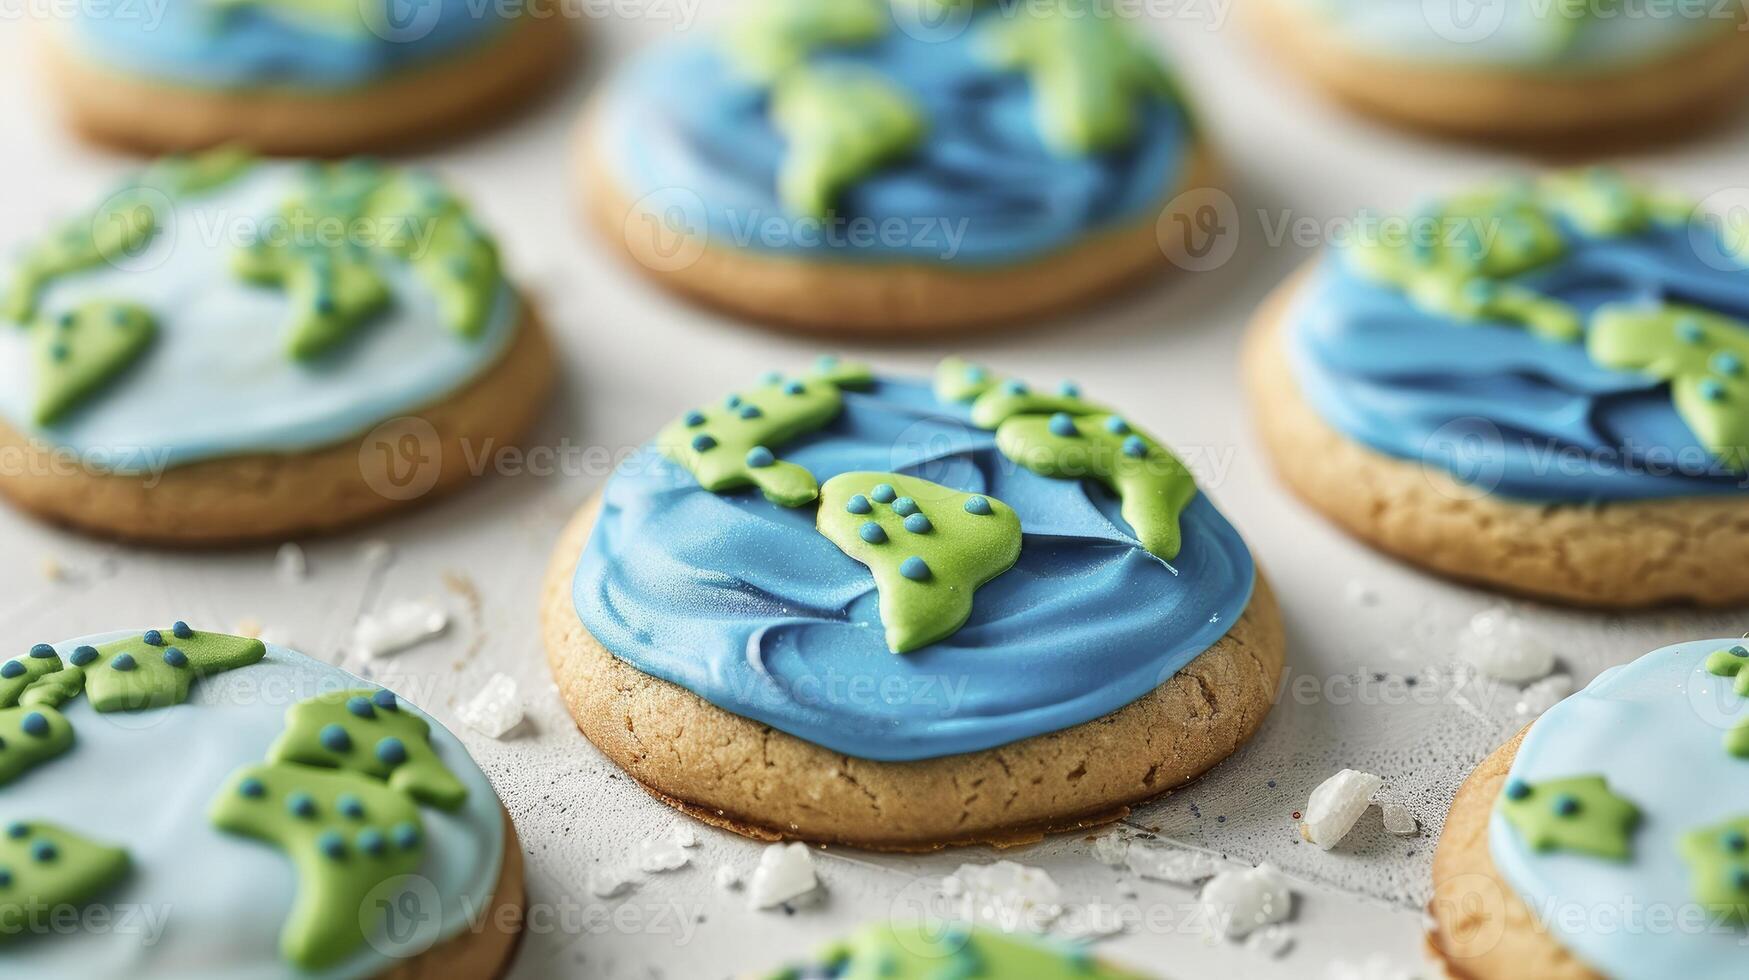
[598,5,1196,264]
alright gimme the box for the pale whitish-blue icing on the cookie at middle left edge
[0,163,521,473]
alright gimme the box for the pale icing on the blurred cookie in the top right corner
[1273,0,1739,70]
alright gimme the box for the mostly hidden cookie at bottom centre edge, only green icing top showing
[759,922,1147,980]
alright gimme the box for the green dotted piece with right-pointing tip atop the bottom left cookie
[84,630,268,712]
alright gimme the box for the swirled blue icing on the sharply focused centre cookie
[574,380,1256,761]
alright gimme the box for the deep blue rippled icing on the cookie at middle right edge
[1287,211,1749,502]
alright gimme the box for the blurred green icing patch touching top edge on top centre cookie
[724,0,890,82]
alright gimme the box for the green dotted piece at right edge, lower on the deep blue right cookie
[1586,305,1749,473]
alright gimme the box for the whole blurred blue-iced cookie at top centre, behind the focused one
[582,0,1212,334]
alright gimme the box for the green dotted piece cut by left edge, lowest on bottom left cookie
[0,821,128,940]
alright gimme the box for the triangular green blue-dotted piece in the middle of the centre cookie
[815,473,1020,653]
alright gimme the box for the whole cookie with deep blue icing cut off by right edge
[1245,170,1749,607]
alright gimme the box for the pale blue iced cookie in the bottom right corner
[1429,641,1749,980]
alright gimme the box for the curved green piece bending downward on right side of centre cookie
[995,415,1196,562]
